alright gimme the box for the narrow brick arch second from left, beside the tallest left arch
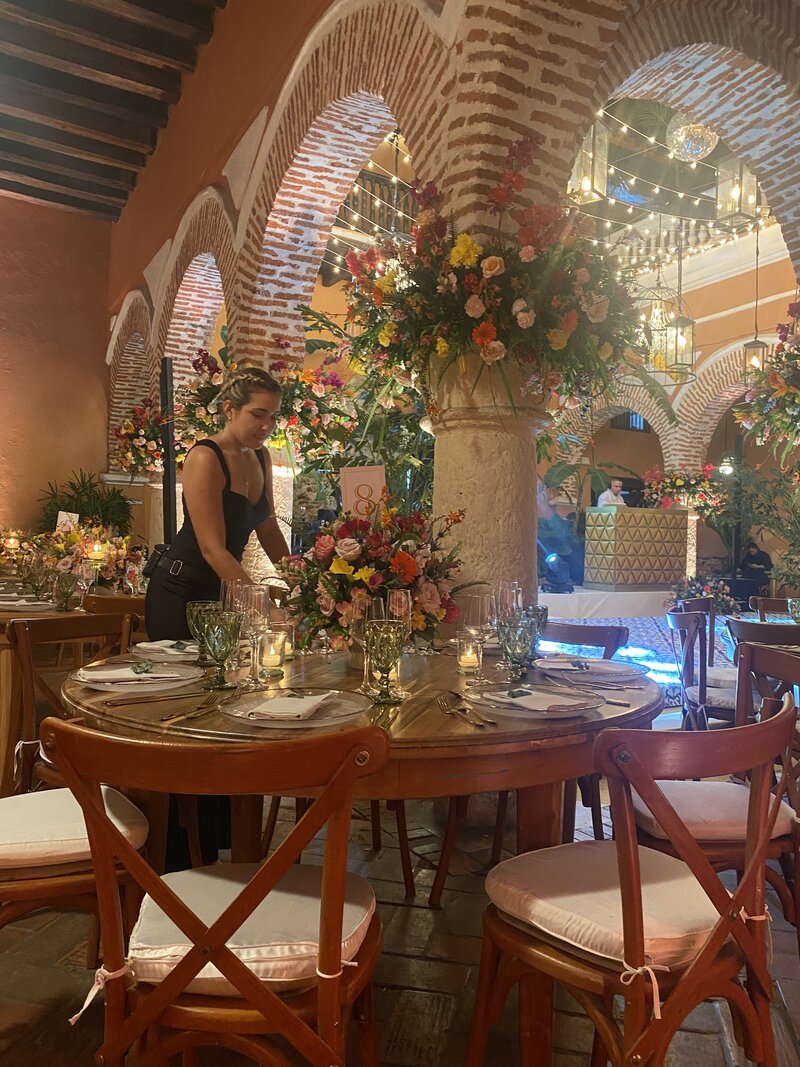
[154,188,236,375]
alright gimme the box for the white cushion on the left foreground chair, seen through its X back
[128,863,375,997]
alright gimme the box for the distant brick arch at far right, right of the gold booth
[672,337,777,466]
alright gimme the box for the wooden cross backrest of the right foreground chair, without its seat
[593,696,797,1049]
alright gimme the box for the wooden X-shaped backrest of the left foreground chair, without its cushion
[42,718,388,1065]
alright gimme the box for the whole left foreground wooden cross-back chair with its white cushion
[42,719,388,1067]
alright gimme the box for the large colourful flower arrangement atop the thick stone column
[337,136,637,408]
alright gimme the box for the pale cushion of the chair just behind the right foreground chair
[633,781,797,842]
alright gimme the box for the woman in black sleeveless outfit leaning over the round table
[145,367,289,641]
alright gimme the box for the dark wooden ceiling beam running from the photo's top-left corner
[0,0,196,70]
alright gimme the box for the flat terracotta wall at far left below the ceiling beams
[0,196,111,526]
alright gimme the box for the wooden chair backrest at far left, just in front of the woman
[5,612,134,792]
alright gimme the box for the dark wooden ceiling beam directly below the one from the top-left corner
[0,17,180,103]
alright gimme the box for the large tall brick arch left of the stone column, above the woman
[230,0,449,362]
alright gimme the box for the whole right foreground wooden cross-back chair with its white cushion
[466,700,796,1067]
